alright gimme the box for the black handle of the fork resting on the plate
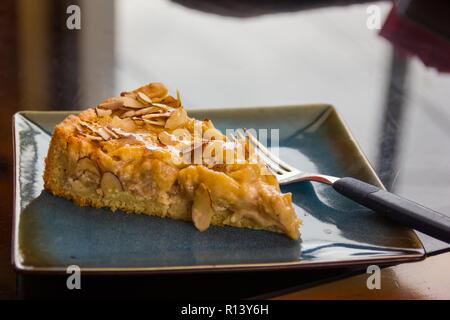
[333,178,450,243]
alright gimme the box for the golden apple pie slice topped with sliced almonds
[44,83,301,239]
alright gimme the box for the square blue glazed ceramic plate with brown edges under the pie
[13,105,424,272]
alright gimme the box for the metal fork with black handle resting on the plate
[241,129,450,243]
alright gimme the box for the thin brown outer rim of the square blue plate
[11,103,426,274]
